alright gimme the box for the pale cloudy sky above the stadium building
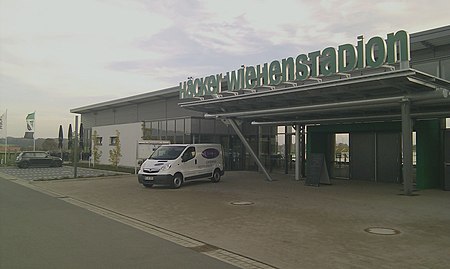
[0,0,450,138]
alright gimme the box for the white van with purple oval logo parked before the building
[138,144,224,188]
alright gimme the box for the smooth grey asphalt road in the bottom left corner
[0,178,236,269]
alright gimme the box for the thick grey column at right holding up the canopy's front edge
[401,98,413,195]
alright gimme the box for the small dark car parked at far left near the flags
[16,151,62,168]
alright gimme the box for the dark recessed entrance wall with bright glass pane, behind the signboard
[307,122,408,183]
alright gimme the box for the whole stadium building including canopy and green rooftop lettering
[70,26,450,195]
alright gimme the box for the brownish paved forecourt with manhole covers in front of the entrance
[22,172,450,268]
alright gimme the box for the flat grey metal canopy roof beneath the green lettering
[180,67,450,124]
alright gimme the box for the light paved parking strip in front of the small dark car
[0,166,125,180]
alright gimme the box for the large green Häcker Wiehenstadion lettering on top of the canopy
[179,30,410,99]
